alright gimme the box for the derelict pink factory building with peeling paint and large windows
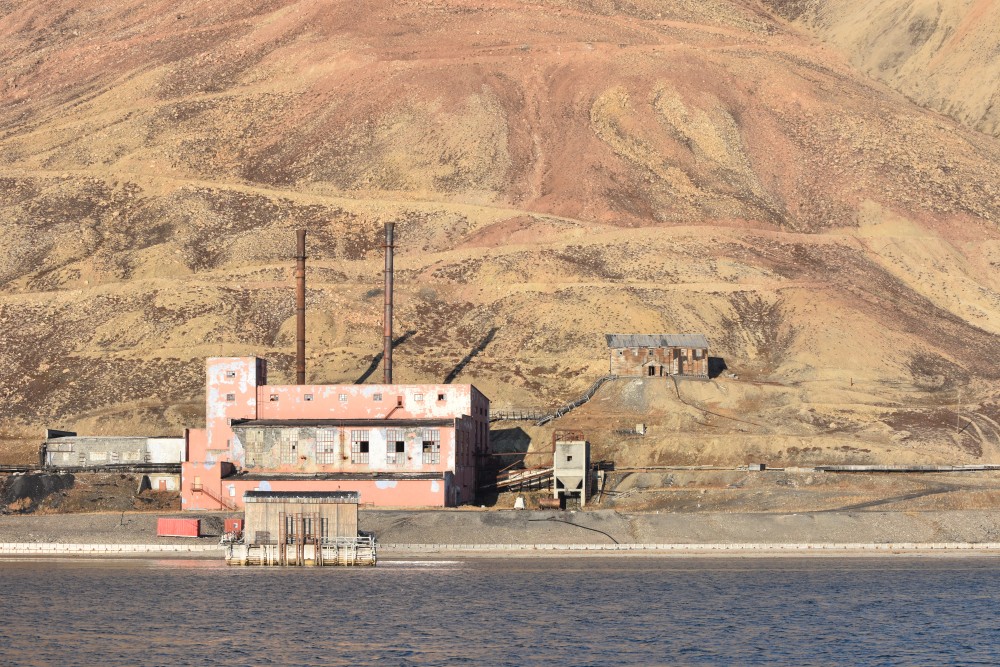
[181,357,489,510]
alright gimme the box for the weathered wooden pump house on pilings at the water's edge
[226,491,376,565]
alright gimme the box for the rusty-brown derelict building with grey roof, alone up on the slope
[606,334,708,378]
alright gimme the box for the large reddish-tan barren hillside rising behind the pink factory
[0,0,1000,463]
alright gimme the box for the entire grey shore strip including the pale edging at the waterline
[0,509,1000,561]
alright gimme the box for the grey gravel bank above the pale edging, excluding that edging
[0,510,1000,545]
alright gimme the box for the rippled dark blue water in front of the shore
[0,558,1000,666]
